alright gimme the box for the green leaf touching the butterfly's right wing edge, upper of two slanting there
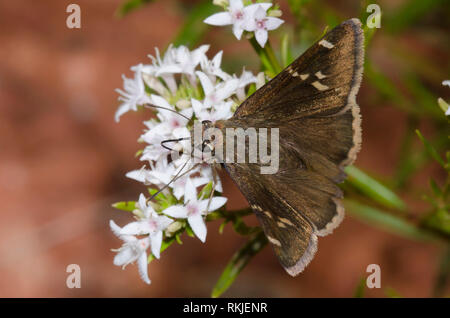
[345,166,406,211]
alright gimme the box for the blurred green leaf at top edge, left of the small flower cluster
[173,1,217,47]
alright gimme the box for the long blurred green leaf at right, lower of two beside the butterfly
[344,199,442,243]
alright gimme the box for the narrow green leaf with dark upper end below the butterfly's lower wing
[211,231,267,298]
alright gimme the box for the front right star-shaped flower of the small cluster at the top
[244,6,284,47]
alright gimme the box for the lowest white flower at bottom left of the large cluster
[109,220,150,284]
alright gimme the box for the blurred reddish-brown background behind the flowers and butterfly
[0,0,448,297]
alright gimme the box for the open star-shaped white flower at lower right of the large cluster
[163,179,227,242]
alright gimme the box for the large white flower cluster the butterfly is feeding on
[110,45,261,283]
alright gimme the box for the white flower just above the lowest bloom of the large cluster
[119,194,173,258]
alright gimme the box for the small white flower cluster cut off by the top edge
[204,0,284,47]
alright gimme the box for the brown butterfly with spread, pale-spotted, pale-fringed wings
[199,19,364,276]
